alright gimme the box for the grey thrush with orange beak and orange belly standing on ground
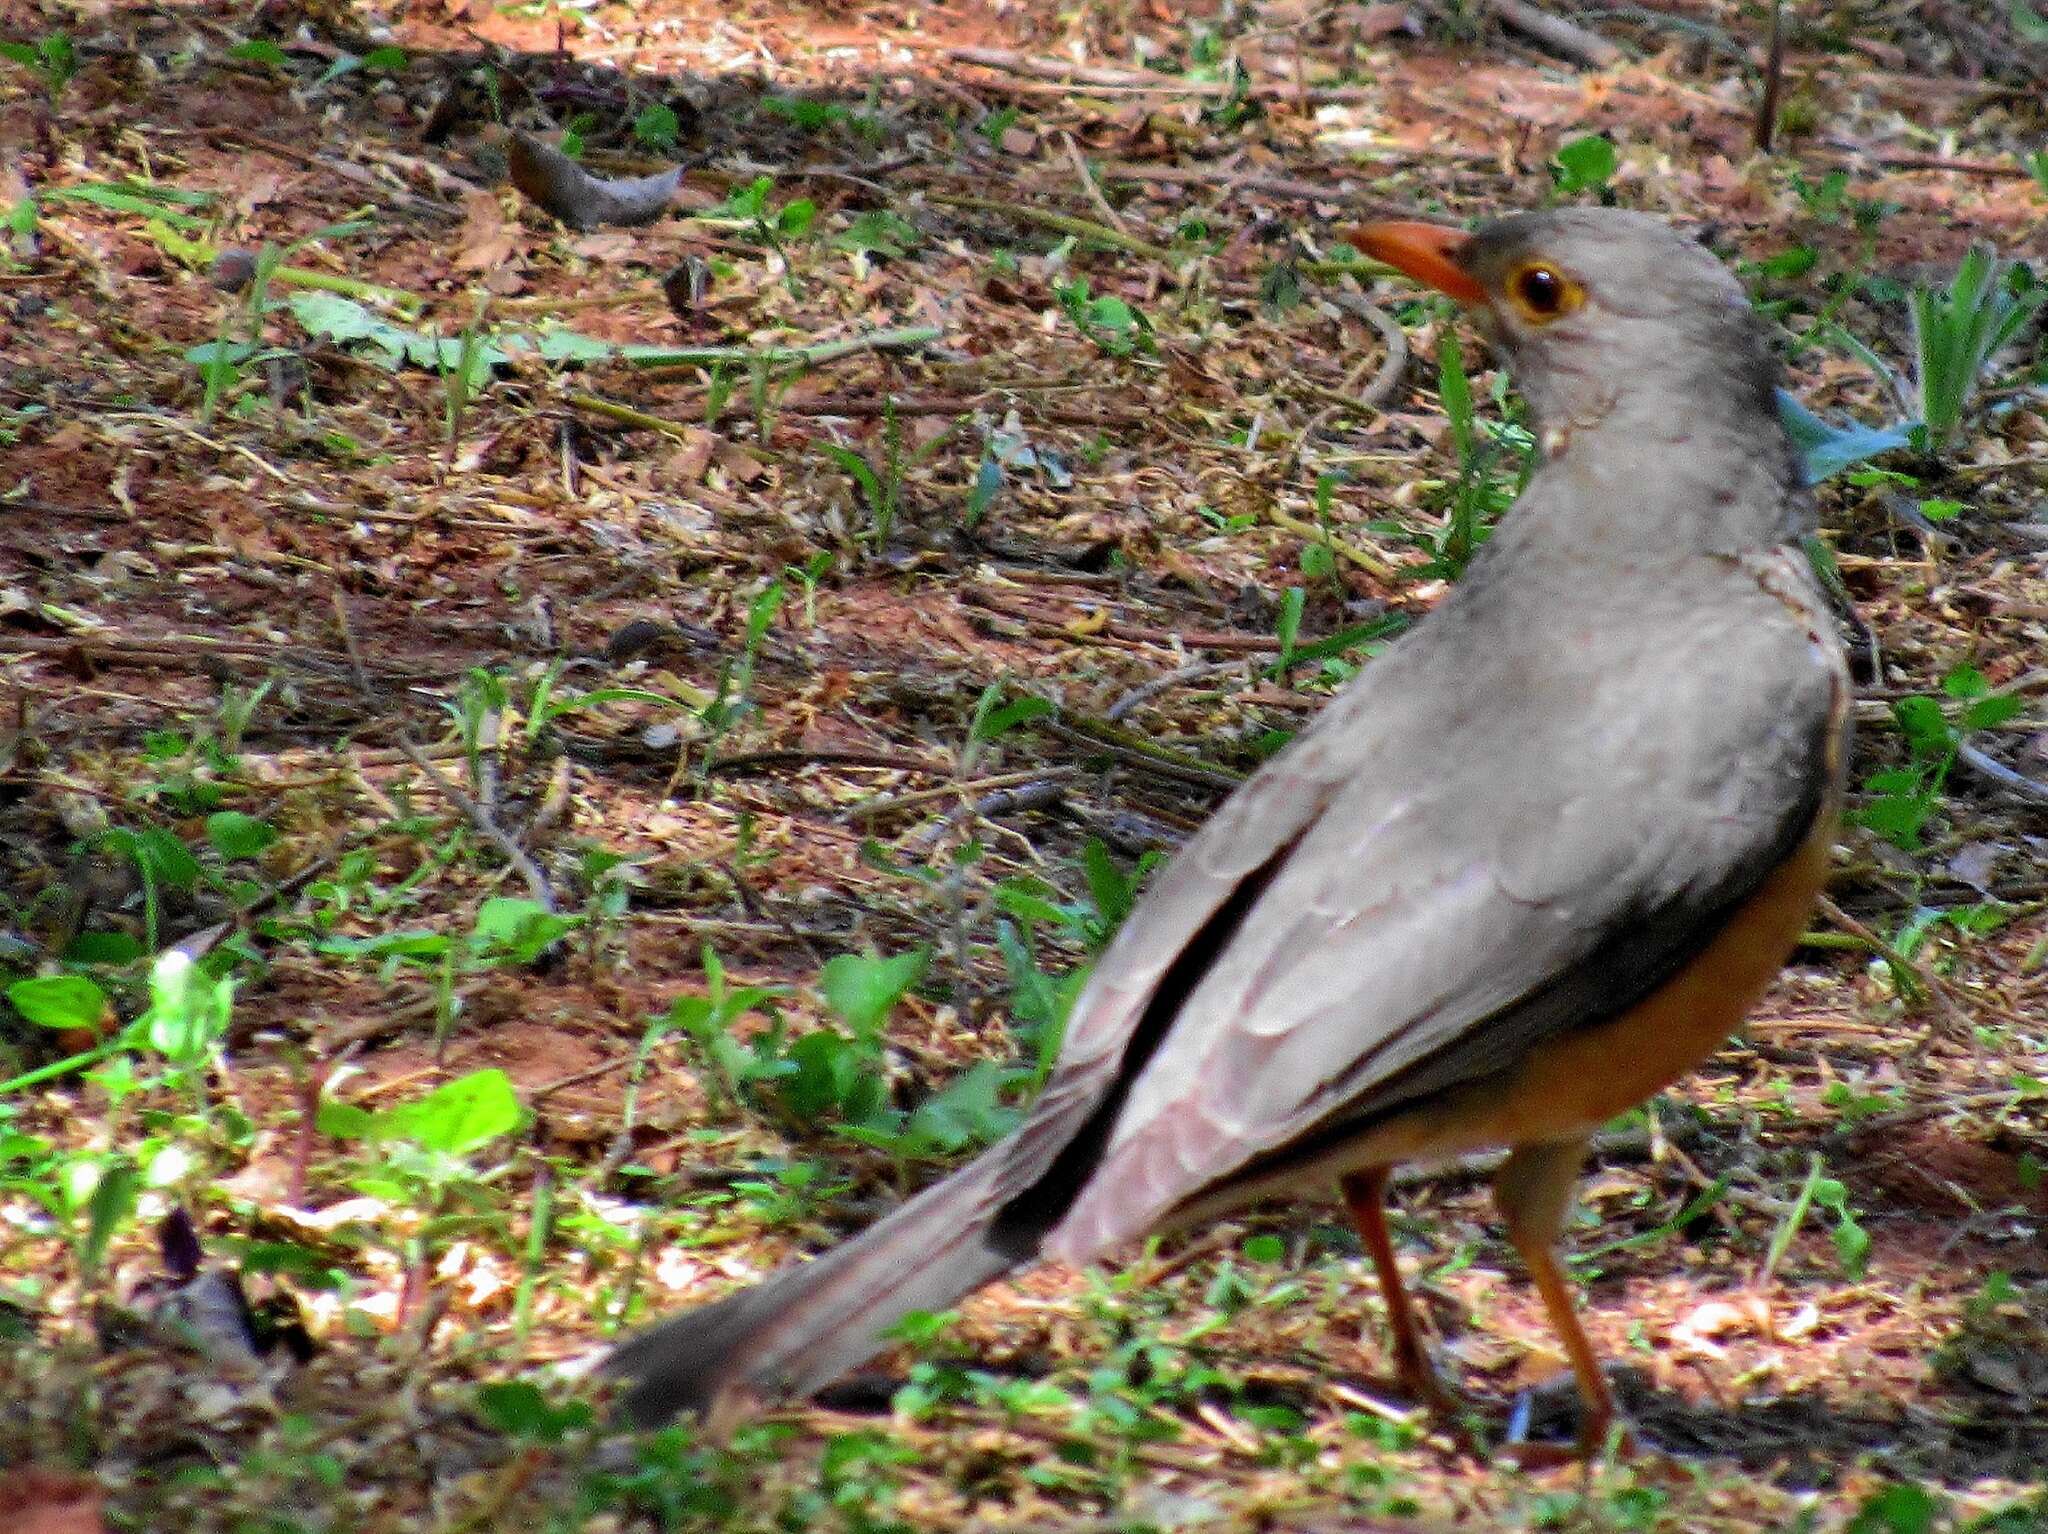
[602,209,1851,1454]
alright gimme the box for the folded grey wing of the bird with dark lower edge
[1044,561,1839,1260]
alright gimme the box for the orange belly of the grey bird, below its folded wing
[1325,815,1833,1171]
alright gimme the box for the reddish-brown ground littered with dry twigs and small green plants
[0,0,2048,1534]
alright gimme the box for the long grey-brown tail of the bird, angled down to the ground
[604,1145,1042,1425]
